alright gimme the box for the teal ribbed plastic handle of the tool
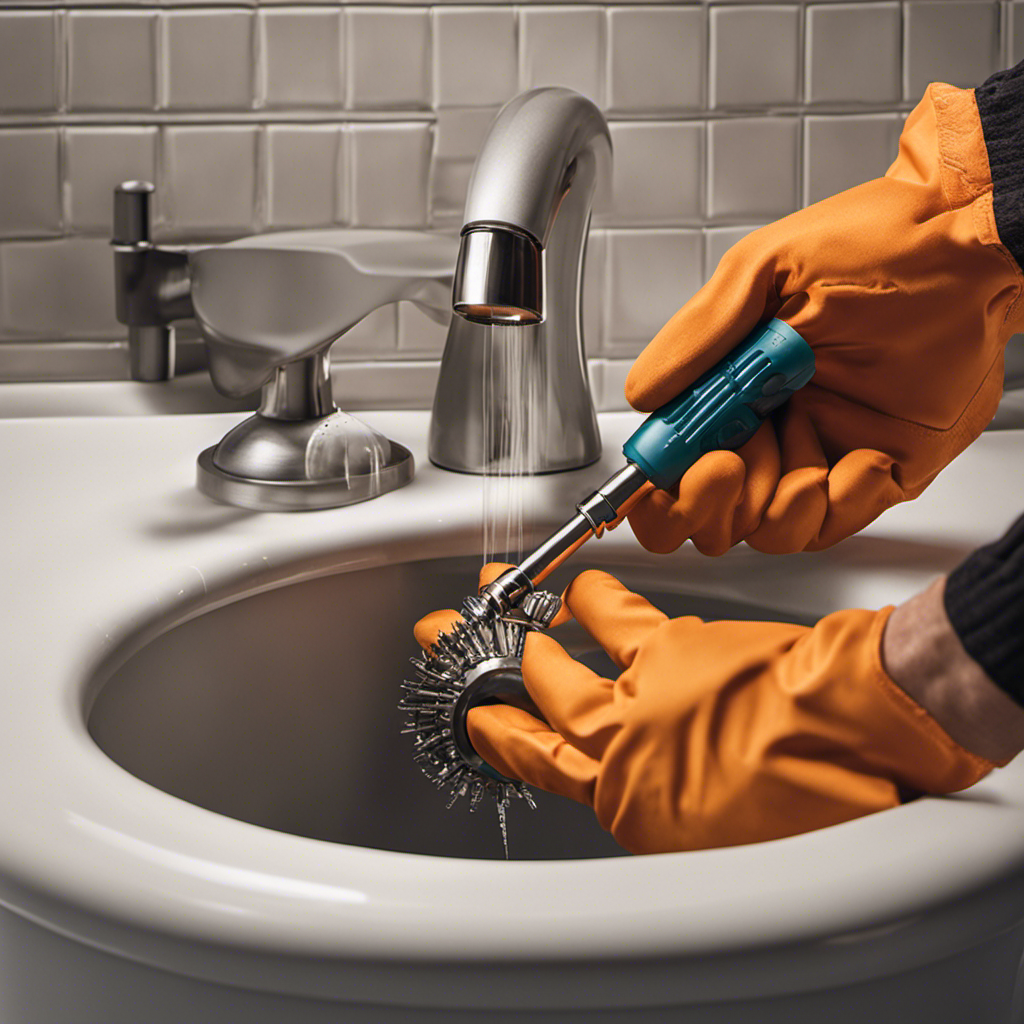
[623,319,814,489]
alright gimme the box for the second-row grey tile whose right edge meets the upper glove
[803,114,903,206]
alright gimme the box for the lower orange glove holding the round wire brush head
[416,565,994,853]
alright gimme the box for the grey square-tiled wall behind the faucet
[0,0,1024,407]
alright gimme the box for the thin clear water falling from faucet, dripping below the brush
[482,326,544,860]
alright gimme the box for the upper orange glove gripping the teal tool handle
[626,84,1024,554]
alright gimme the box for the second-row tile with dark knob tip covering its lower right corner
[65,126,162,234]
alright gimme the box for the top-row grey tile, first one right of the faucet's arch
[608,5,707,113]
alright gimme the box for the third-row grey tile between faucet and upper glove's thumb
[604,230,703,355]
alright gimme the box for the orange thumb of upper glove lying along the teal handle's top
[625,237,778,413]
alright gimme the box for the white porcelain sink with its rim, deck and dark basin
[6,413,1024,1024]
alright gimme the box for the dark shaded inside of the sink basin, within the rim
[88,558,806,860]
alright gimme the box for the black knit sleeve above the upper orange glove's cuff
[974,60,1024,266]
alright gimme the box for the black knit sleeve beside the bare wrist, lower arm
[945,515,1024,706]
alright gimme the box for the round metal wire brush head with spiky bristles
[398,591,561,811]
